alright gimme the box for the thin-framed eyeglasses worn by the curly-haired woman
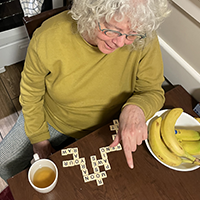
[98,22,146,41]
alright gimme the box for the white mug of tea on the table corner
[28,154,58,193]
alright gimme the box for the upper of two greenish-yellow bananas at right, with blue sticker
[175,129,200,141]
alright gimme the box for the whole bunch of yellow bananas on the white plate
[148,108,200,166]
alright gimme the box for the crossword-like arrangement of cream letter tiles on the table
[61,120,122,186]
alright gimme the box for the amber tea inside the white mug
[33,167,56,188]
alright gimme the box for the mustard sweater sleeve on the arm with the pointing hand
[123,37,165,120]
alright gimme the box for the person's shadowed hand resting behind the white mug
[33,140,55,158]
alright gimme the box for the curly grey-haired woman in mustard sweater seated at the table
[0,0,169,180]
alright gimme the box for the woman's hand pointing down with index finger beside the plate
[110,105,147,169]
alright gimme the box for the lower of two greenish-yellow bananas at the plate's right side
[180,140,200,155]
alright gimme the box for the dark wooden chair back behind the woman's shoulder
[23,1,72,39]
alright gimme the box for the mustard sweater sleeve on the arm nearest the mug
[20,34,50,144]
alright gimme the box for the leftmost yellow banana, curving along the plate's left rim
[148,117,182,166]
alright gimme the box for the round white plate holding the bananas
[145,109,200,171]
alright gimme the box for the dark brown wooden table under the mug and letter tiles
[8,86,200,200]
